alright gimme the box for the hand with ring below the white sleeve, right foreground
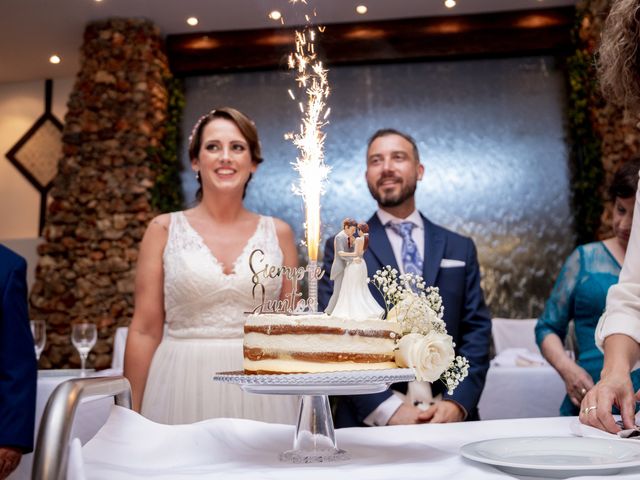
[579,373,636,433]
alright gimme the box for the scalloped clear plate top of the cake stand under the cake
[213,368,416,395]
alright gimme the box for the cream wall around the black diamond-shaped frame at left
[0,77,74,241]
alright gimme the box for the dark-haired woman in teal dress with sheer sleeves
[536,159,640,416]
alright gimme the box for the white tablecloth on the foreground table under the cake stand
[82,407,640,480]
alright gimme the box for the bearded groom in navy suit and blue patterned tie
[318,129,491,427]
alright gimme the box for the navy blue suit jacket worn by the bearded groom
[318,214,491,427]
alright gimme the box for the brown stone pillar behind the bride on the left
[30,19,169,368]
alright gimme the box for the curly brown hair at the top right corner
[597,0,640,110]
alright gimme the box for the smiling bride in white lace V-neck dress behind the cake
[124,108,297,424]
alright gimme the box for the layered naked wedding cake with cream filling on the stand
[244,314,402,374]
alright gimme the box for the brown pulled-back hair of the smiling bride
[189,107,264,202]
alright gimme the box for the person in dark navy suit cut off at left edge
[0,245,38,479]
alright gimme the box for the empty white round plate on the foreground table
[460,437,640,478]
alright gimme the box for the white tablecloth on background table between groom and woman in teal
[478,363,567,420]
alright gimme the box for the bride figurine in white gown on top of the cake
[331,223,384,320]
